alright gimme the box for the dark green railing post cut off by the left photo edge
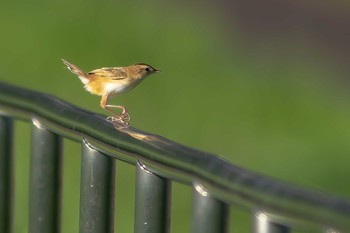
[0,115,13,233]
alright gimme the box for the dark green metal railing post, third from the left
[79,140,115,233]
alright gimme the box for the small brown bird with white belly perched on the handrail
[62,59,160,125]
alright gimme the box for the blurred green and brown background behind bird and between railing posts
[0,0,350,233]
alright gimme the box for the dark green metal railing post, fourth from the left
[134,161,171,233]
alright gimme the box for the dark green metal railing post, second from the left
[29,120,62,233]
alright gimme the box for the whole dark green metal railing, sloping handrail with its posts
[0,80,350,233]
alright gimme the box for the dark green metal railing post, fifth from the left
[192,184,229,233]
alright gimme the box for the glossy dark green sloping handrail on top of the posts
[0,82,350,232]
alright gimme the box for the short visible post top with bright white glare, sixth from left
[254,211,290,233]
